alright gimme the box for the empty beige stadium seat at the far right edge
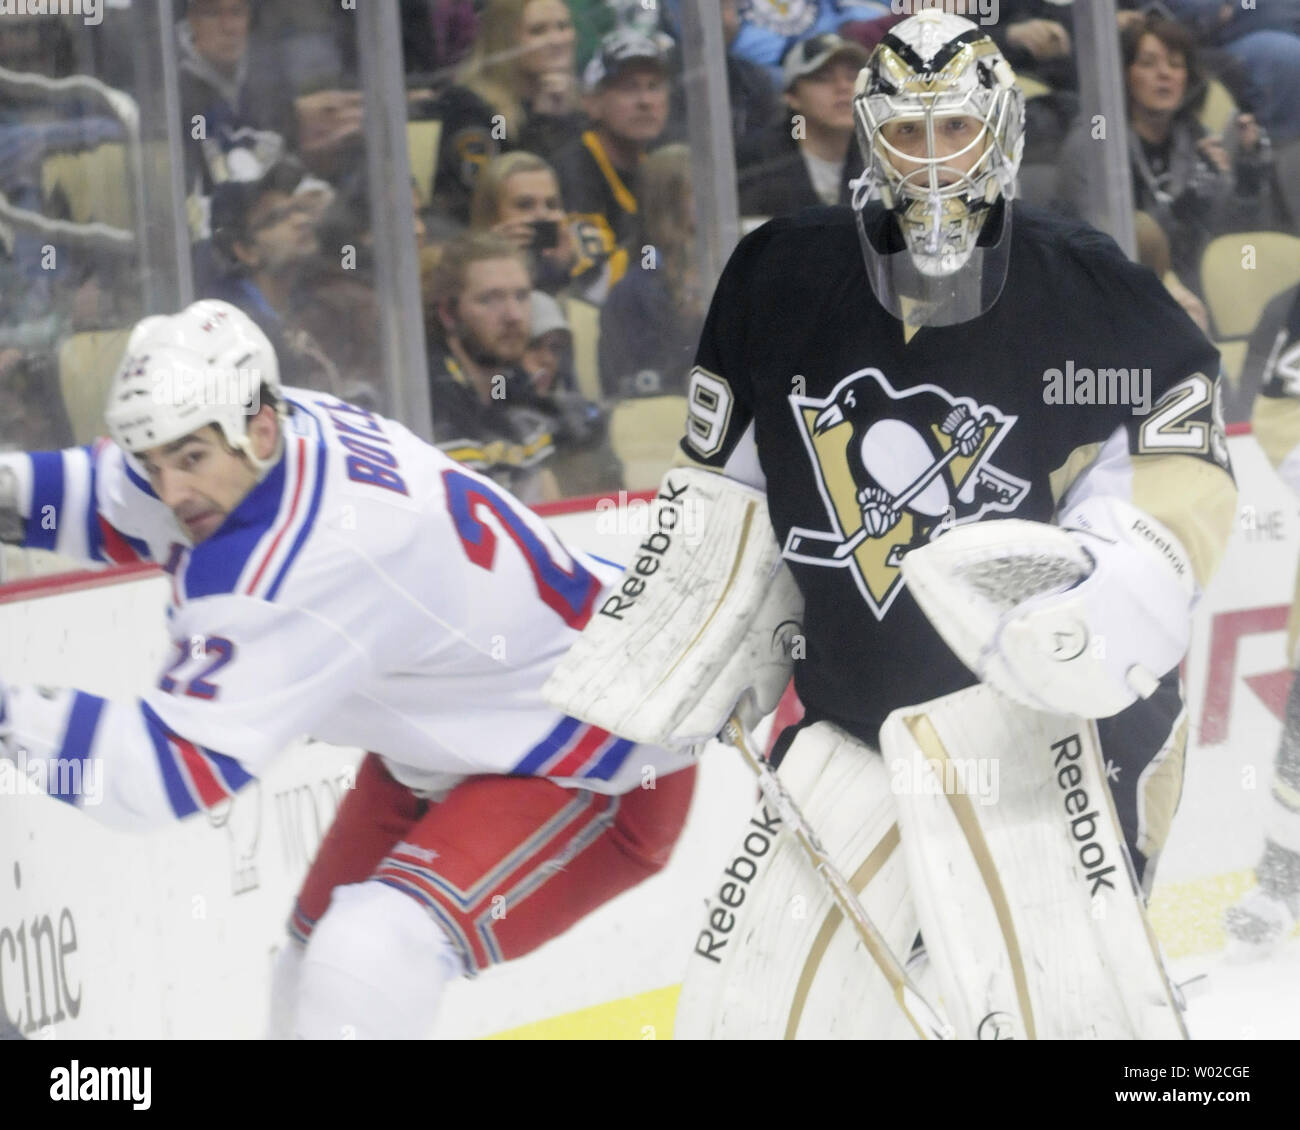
[1201,231,1300,339]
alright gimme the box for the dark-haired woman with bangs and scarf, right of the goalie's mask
[1057,17,1270,293]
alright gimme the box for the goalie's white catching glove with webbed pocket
[902,497,1196,718]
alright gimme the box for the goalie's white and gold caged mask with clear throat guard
[853,9,1024,325]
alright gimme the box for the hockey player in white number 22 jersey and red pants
[0,302,694,1038]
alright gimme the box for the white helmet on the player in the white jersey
[104,299,283,473]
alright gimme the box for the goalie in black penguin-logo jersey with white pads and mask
[547,10,1235,1039]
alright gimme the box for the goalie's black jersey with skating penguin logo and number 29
[683,204,1235,756]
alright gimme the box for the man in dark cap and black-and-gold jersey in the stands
[553,29,668,302]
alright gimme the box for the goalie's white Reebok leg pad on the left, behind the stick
[673,723,917,1039]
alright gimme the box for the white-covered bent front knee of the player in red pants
[294,880,463,1040]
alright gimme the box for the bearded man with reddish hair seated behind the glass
[424,233,559,503]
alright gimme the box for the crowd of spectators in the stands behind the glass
[0,0,1300,491]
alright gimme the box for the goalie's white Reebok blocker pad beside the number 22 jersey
[543,467,803,748]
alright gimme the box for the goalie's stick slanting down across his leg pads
[719,714,954,1040]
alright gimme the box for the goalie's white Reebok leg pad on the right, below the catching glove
[880,687,1186,1039]
